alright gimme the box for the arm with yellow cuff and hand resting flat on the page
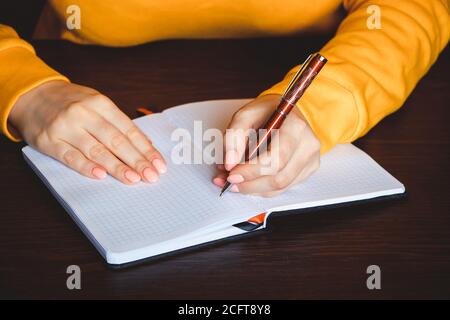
[0,25,166,184]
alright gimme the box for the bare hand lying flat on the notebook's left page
[8,81,167,184]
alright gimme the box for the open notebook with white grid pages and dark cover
[23,100,405,265]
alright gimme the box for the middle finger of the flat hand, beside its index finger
[81,116,159,183]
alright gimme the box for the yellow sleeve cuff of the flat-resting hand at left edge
[0,24,69,141]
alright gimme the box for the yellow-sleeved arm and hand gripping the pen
[220,0,450,196]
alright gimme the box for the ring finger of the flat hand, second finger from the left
[67,132,141,184]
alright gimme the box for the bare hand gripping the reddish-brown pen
[213,95,320,197]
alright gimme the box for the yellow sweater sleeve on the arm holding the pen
[261,0,450,153]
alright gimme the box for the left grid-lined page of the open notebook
[23,114,259,252]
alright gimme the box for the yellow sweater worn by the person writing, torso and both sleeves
[0,0,450,152]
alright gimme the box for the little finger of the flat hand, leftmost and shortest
[46,142,107,179]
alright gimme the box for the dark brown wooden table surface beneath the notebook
[0,36,450,299]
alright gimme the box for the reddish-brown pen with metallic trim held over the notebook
[220,52,327,197]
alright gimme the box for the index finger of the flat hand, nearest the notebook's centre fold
[85,95,167,173]
